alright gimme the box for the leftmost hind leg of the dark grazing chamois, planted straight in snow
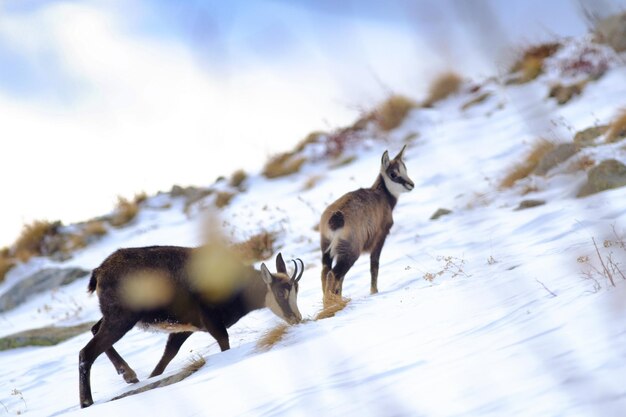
[78,318,136,408]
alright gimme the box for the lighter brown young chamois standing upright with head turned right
[320,145,415,299]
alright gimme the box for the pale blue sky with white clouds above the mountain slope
[0,0,626,246]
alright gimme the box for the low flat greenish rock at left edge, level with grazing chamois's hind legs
[0,321,95,351]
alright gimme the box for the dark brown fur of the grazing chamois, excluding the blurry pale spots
[79,246,301,407]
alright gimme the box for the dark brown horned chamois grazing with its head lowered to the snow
[78,246,304,408]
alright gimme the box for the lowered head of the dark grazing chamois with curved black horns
[261,253,304,324]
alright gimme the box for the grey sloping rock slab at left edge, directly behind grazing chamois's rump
[0,268,91,312]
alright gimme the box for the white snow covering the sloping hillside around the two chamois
[0,33,626,417]
